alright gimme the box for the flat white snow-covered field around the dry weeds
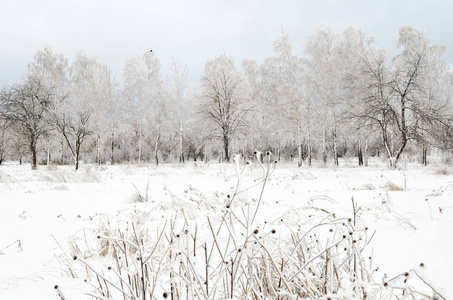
[0,158,453,300]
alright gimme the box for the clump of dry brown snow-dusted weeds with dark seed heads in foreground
[54,151,441,300]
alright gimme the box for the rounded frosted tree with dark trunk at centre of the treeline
[199,54,252,162]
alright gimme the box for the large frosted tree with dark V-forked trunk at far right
[349,27,449,167]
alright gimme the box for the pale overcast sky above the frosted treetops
[0,0,453,86]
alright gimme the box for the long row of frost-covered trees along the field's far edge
[0,27,453,169]
